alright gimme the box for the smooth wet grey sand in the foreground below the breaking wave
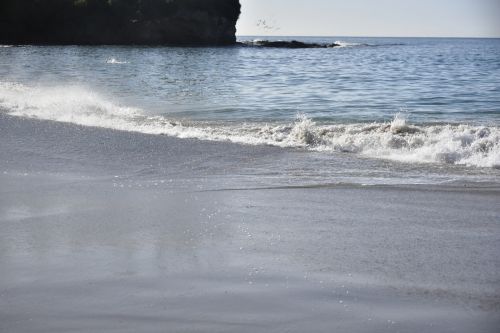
[0,115,500,332]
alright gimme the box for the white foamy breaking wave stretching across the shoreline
[0,82,500,168]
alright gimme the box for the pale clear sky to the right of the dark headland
[237,0,500,37]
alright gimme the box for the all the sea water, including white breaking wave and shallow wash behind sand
[0,36,500,183]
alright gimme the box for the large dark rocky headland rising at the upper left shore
[0,0,241,45]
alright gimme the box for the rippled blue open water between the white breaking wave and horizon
[0,37,500,124]
